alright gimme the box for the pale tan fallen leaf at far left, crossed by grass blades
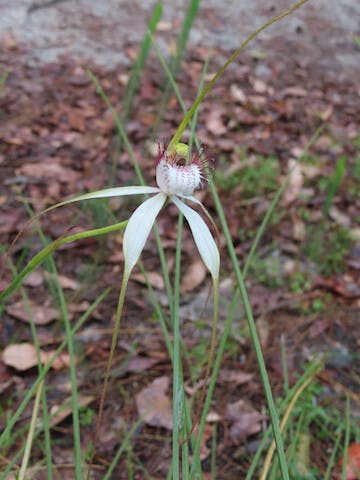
[2,343,70,372]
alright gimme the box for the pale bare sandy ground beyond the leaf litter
[0,0,360,80]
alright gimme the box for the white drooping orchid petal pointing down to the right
[171,196,220,279]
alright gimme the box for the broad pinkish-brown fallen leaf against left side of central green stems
[136,377,172,430]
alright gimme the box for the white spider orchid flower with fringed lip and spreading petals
[64,143,220,279]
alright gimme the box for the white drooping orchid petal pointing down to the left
[123,193,166,275]
